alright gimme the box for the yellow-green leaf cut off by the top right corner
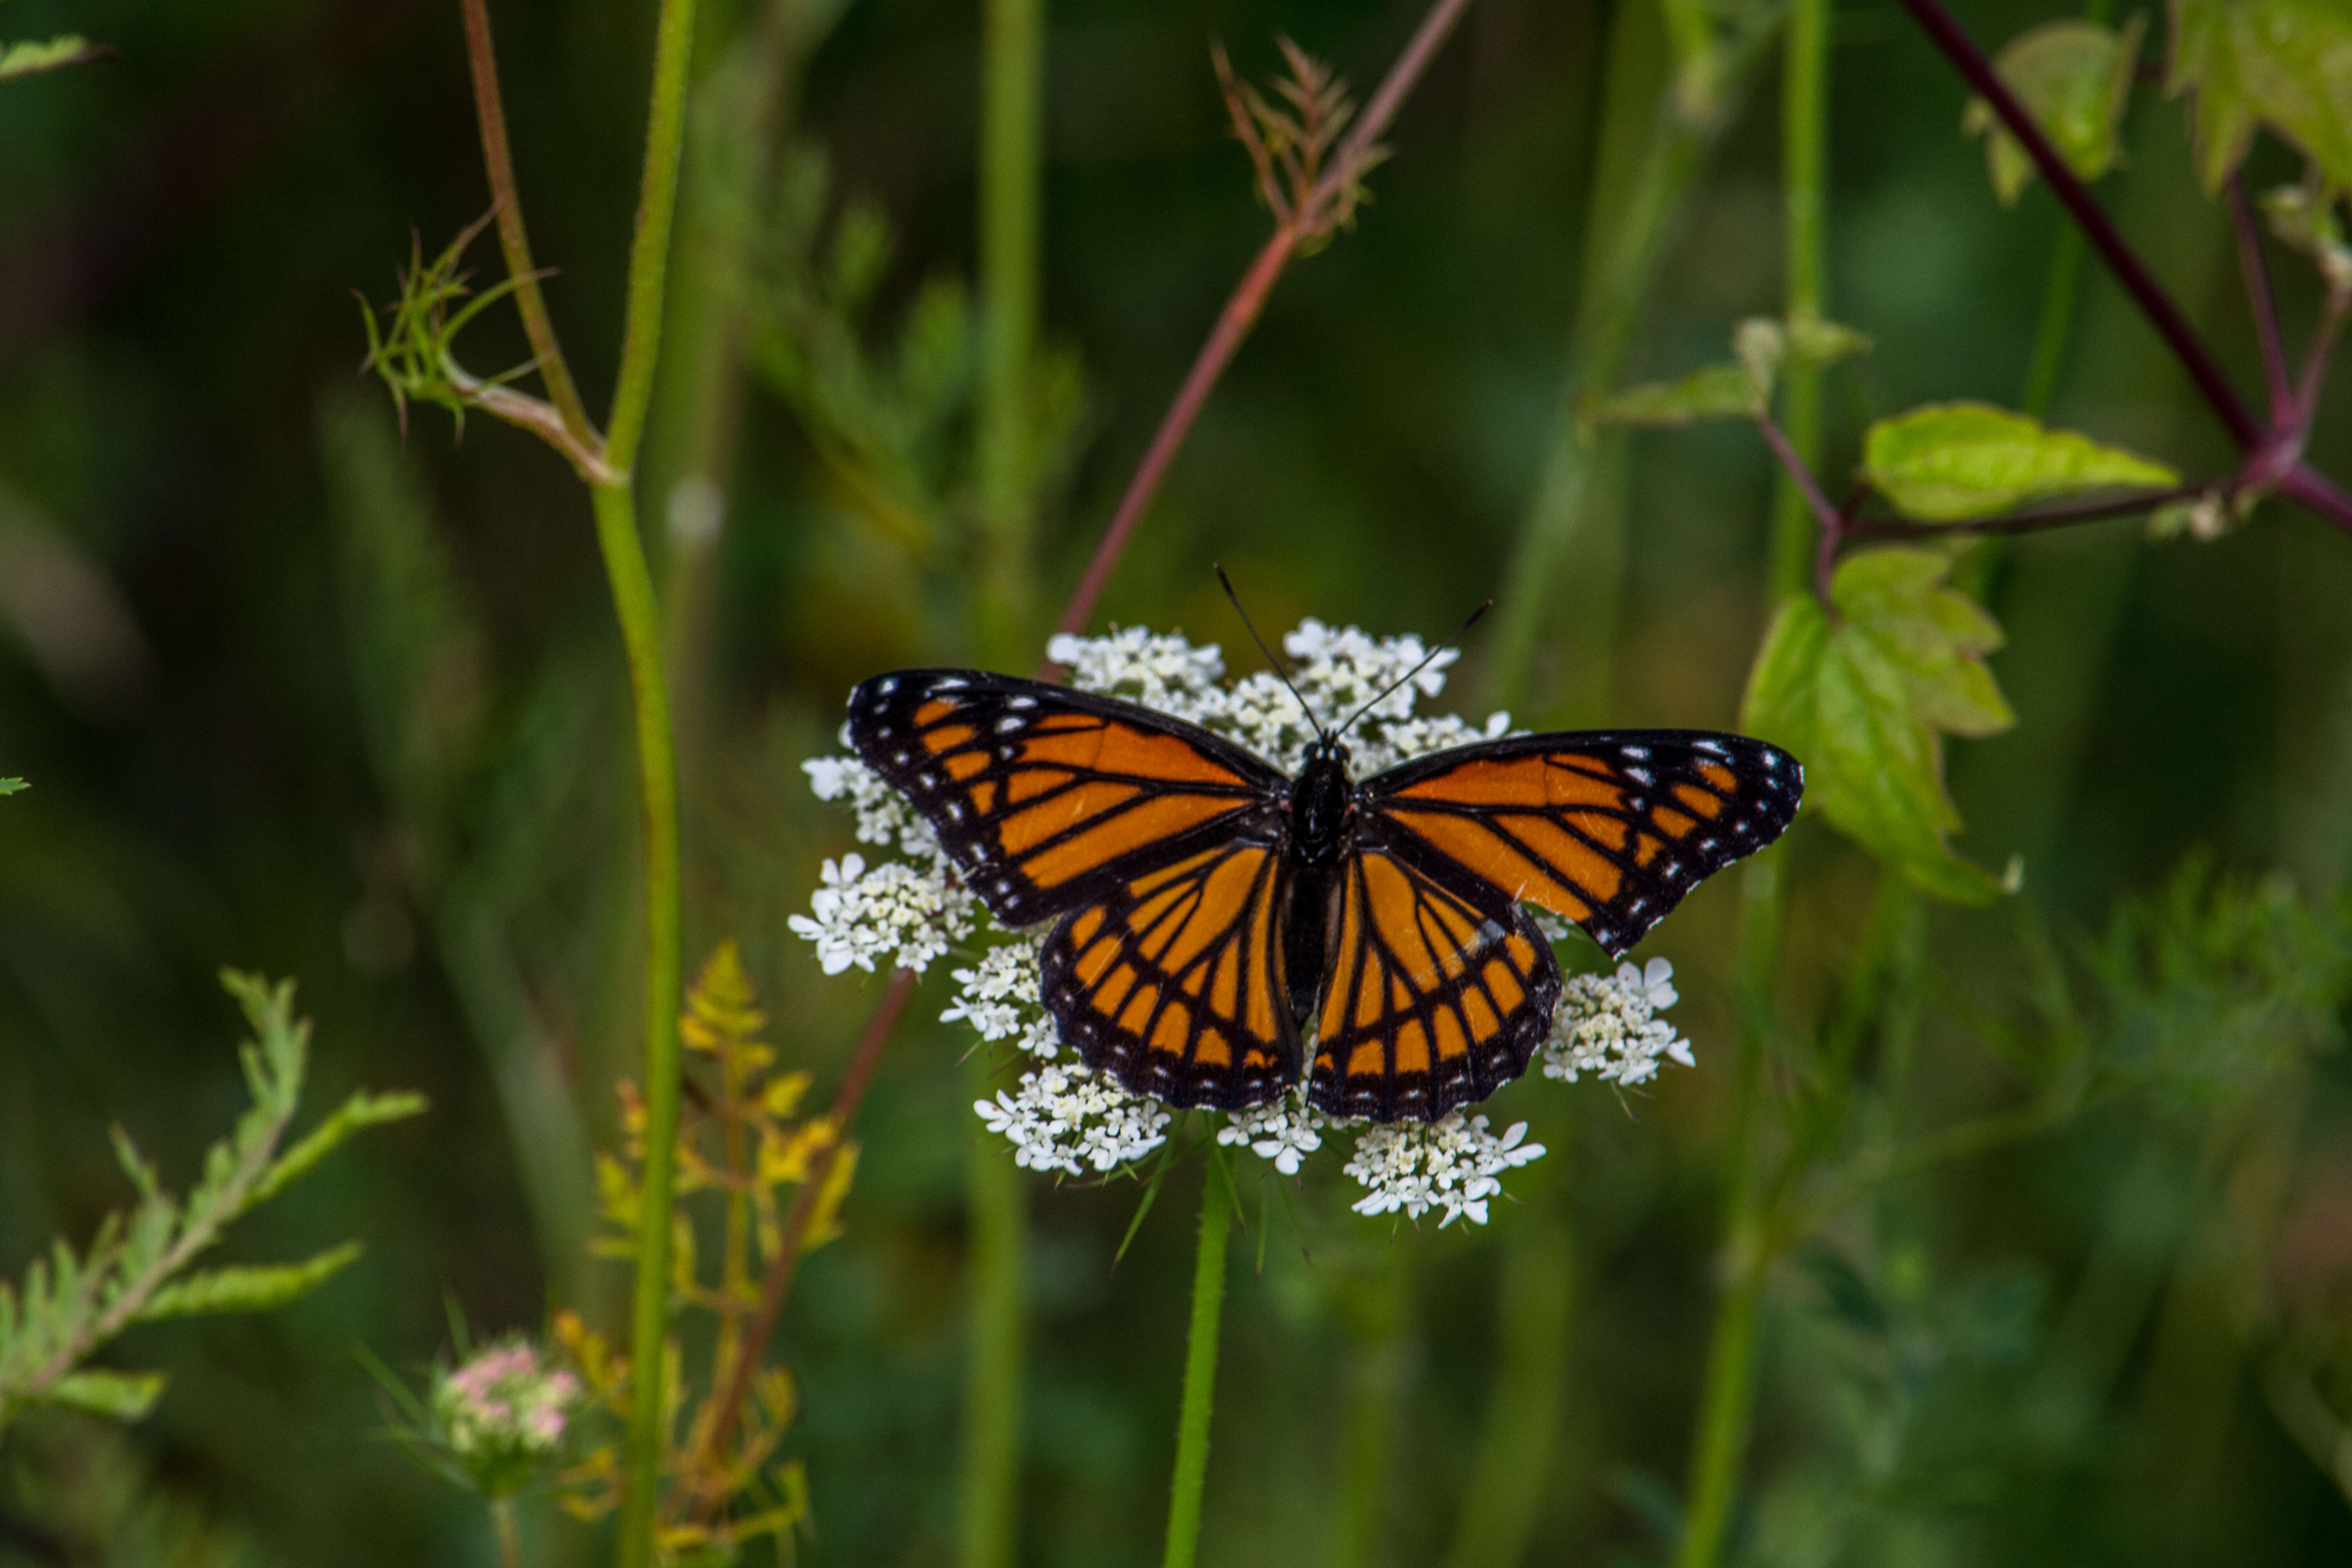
[2164,0,2352,193]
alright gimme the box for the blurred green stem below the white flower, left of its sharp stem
[957,1051,1028,1568]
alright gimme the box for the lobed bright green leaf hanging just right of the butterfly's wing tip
[1743,550,2013,903]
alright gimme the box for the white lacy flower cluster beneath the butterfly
[790,621,1691,1225]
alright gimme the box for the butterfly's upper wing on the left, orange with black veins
[849,670,1287,926]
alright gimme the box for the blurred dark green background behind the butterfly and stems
[0,0,2352,1568]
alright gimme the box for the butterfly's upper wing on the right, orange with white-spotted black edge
[1359,729,1804,957]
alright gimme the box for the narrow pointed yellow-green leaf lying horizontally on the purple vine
[1863,402,2180,522]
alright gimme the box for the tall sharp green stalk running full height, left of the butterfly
[593,0,694,1568]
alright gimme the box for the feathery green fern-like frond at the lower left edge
[0,971,426,1429]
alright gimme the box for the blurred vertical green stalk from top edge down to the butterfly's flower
[978,0,1044,670]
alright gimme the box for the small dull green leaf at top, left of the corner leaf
[1959,14,2147,205]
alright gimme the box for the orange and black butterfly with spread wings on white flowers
[849,665,1804,1122]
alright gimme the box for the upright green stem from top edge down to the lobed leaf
[1771,0,1830,602]
